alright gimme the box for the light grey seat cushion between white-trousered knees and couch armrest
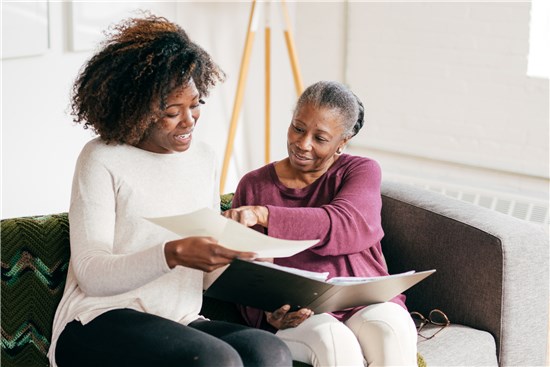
[418,324,498,366]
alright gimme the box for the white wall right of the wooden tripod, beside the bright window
[296,1,549,220]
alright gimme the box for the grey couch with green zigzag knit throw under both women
[1,182,549,367]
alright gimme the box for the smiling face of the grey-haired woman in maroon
[287,103,348,176]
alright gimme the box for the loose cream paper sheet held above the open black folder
[145,208,319,258]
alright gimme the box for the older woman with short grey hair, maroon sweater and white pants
[225,82,417,366]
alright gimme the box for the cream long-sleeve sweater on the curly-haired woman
[49,138,219,366]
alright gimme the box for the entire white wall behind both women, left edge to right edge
[2,2,548,218]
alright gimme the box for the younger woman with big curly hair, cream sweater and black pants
[49,16,292,367]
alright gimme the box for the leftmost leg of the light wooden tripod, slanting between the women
[220,0,258,192]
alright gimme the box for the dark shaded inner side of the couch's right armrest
[382,196,504,354]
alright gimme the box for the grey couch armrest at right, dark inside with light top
[382,182,549,366]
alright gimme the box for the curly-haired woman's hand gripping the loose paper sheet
[164,237,256,272]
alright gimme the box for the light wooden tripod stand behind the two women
[220,0,304,192]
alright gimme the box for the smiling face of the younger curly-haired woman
[137,80,201,154]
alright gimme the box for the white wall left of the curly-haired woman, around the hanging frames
[2,3,94,218]
